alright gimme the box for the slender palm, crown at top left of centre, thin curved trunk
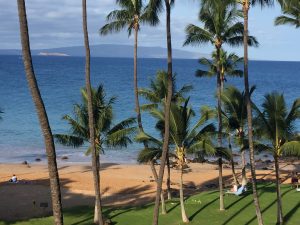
[100,0,159,142]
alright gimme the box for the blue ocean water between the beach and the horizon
[0,56,300,163]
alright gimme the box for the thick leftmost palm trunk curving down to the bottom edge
[17,0,64,225]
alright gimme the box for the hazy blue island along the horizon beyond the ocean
[0,44,209,59]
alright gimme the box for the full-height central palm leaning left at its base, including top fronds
[149,0,175,225]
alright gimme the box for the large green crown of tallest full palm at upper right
[184,0,258,49]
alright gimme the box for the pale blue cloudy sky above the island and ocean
[0,0,300,61]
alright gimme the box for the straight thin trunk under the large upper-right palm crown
[217,47,225,210]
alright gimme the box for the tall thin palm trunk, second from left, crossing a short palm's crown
[82,0,103,225]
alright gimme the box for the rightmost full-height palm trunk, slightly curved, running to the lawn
[243,0,263,225]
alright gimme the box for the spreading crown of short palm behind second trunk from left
[55,85,136,154]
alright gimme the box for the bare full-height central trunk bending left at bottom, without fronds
[152,0,173,225]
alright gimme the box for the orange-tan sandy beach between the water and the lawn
[0,163,299,220]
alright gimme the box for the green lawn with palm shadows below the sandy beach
[0,183,300,225]
